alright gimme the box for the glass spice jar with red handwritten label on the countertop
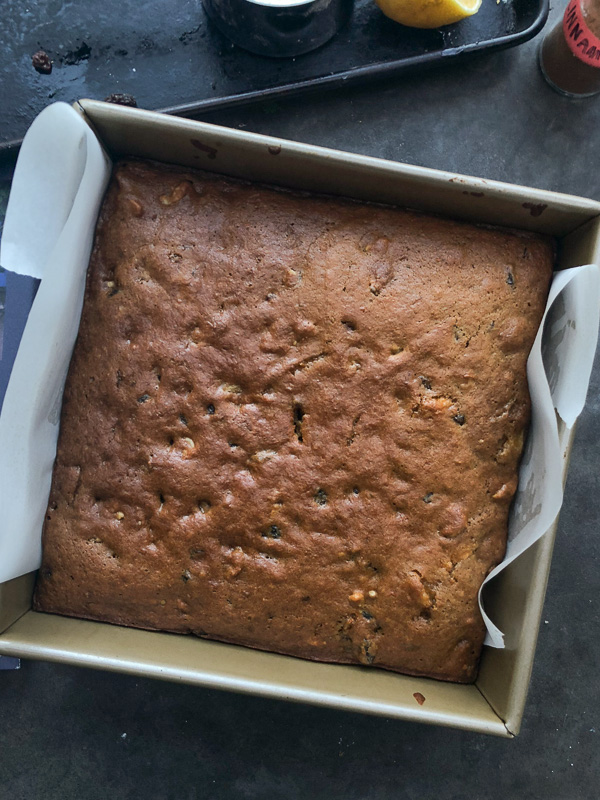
[540,0,600,97]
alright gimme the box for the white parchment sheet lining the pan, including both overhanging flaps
[0,103,600,647]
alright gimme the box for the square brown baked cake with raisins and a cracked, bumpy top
[36,162,552,681]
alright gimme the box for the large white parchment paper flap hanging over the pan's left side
[0,103,110,582]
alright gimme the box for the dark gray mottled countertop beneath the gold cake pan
[0,0,600,800]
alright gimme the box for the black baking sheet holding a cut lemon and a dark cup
[0,0,548,148]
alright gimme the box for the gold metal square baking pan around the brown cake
[0,100,600,737]
